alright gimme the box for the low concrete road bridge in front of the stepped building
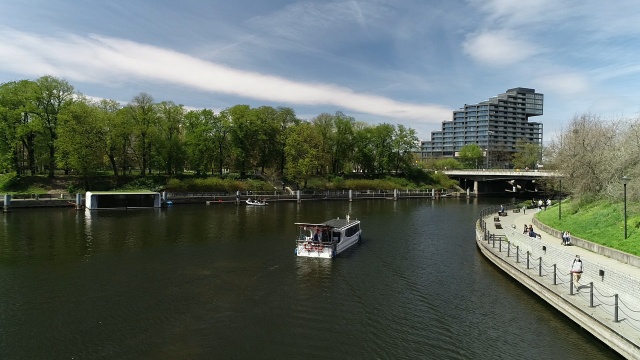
[441,169,562,196]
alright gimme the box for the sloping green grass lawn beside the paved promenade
[535,200,640,256]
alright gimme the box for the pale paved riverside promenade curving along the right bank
[477,209,640,359]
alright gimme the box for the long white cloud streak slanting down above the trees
[0,30,451,123]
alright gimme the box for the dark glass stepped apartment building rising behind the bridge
[421,87,544,168]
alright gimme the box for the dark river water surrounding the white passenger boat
[0,199,618,360]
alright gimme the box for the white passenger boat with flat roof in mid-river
[295,215,362,259]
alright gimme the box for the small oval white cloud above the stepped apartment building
[462,30,540,66]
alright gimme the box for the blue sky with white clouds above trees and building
[0,0,640,142]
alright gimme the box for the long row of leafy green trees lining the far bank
[0,75,428,184]
